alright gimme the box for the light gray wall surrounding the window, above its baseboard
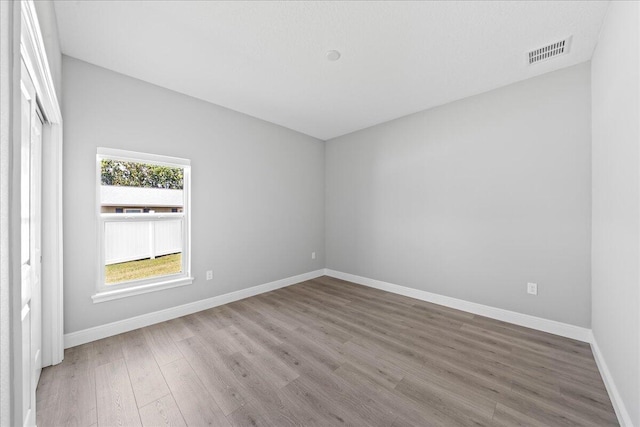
[62,56,325,333]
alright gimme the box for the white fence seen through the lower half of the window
[104,218,183,265]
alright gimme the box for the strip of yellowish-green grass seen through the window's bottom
[104,253,182,285]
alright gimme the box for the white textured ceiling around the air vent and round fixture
[55,1,608,140]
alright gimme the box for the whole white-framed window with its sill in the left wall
[93,148,193,303]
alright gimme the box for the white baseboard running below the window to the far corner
[64,270,324,348]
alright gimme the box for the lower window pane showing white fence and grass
[104,218,183,285]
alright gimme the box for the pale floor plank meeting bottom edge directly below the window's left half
[96,359,142,426]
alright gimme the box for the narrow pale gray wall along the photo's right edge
[591,2,640,426]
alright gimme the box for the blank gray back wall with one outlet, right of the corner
[325,63,591,327]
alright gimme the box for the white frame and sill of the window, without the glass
[91,147,193,303]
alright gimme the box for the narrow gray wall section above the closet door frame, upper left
[34,1,62,101]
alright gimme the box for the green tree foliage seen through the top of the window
[100,160,184,190]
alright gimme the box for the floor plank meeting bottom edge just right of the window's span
[160,358,230,426]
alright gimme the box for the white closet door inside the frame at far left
[20,59,42,426]
